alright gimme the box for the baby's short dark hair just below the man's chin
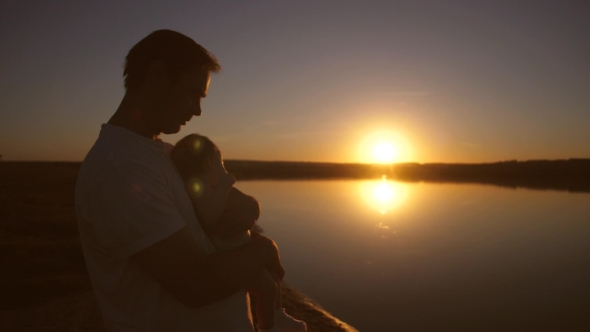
[170,134,219,181]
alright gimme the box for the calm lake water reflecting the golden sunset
[237,180,590,331]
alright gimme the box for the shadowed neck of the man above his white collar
[108,91,159,140]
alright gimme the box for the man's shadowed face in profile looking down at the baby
[154,68,211,134]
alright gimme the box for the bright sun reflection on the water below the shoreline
[361,175,407,214]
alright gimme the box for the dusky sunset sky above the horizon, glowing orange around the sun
[0,0,590,162]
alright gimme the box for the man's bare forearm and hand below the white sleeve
[132,227,278,308]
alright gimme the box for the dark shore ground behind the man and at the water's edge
[0,162,355,332]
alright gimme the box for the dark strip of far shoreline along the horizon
[0,159,590,193]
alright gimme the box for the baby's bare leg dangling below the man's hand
[246,269,280,330]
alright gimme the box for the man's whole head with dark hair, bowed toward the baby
[123,30,221,135]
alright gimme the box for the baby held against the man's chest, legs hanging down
[170,134,307,332]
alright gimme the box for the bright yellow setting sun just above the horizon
[358,131,411,164]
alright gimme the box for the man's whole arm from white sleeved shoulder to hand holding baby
[87,159,278,307]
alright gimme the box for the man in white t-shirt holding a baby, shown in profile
[76,30,281,332]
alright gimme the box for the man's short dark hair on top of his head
[123,30,221,90]
